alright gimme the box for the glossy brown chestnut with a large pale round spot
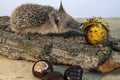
[32,60,53,78]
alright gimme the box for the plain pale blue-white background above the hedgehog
[0,0,120,18]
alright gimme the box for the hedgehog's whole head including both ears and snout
[49,3,81,33]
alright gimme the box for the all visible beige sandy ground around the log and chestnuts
[0,18,120,80]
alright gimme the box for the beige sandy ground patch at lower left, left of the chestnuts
[0,56,38,80]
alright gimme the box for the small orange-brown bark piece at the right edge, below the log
[98,51,120,73]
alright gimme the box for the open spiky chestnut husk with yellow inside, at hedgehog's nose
[82,17,109,45]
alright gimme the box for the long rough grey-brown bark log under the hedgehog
[0,17,119,70]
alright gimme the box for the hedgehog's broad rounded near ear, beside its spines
[49,11,60,28]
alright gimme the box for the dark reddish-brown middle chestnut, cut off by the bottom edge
[42,71,64,80]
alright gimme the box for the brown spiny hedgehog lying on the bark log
[10,2,82,35]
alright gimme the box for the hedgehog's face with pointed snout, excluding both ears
[58,12,82,32]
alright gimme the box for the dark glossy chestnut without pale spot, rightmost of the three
[64,65,83,80]
